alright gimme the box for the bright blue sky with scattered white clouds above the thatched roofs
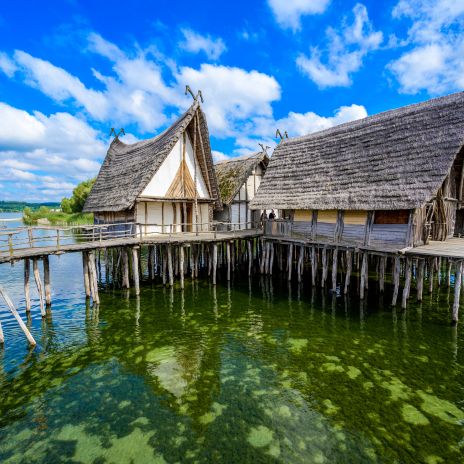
[0,0,464,201]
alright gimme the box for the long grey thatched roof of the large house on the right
[251,92,464,210]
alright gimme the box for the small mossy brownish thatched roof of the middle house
[214,152,269,205]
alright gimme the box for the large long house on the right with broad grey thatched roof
[251,93,464,249]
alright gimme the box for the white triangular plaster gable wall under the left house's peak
[140,135,209,198]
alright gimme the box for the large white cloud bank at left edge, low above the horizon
[0,102,106,201]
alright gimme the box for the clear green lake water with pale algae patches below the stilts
[0,212,464,463]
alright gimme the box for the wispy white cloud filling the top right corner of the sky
[388,0,464,94]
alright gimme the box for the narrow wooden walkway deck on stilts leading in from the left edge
[0,229,262,264]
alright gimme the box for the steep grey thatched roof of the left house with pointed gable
[84,100,221,212]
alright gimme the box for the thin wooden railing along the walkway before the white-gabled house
[0,222,260,258]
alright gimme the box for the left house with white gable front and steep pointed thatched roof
[84,100,221,234]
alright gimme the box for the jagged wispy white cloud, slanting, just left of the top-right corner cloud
[296,3,383,88]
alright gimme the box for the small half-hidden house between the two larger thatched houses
[214,152,269,229]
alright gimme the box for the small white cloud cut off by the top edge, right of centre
[268,0,330,31]
